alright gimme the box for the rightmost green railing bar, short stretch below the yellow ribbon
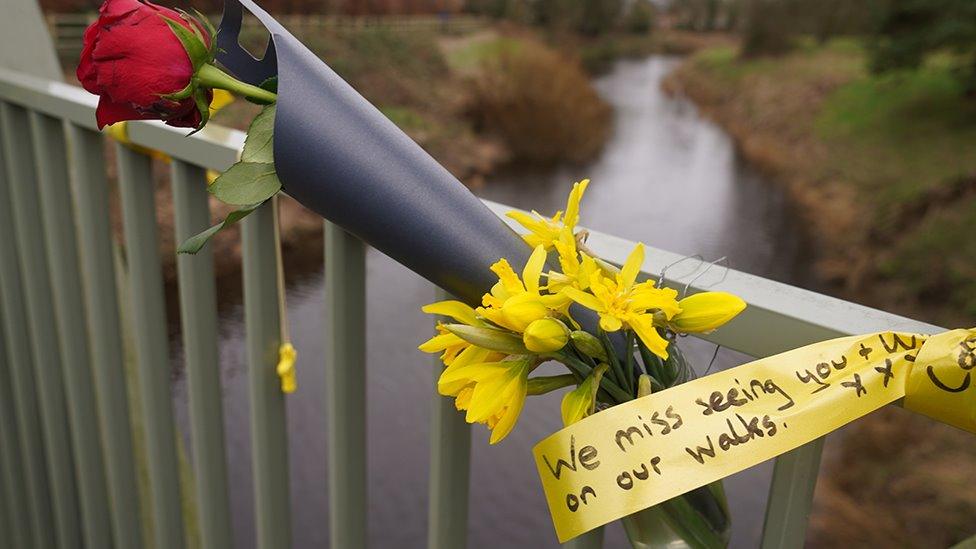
[762,437,824,549]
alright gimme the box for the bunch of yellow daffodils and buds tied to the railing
[420,180,745,444]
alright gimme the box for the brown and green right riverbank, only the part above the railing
[666,41,976,326]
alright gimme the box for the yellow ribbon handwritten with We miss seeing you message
[533,329,976,542]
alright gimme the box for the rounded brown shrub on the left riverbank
[469,42,610,164]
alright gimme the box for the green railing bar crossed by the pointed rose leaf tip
[172,160,233,549]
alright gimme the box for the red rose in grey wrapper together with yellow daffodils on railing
[77,0,745,547]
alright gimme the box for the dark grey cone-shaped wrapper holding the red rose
[217,0,530,304]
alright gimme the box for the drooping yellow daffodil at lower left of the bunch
[438,356,534,444]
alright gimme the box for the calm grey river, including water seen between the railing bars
[174,55,805,549]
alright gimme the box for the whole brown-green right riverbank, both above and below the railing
[666,37,976,547]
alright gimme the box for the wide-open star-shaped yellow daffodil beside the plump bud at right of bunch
[562,244,681,358]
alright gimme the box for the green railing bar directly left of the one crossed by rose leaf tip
[116,145,184,549]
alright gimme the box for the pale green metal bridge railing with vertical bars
[0,65,940,548]
